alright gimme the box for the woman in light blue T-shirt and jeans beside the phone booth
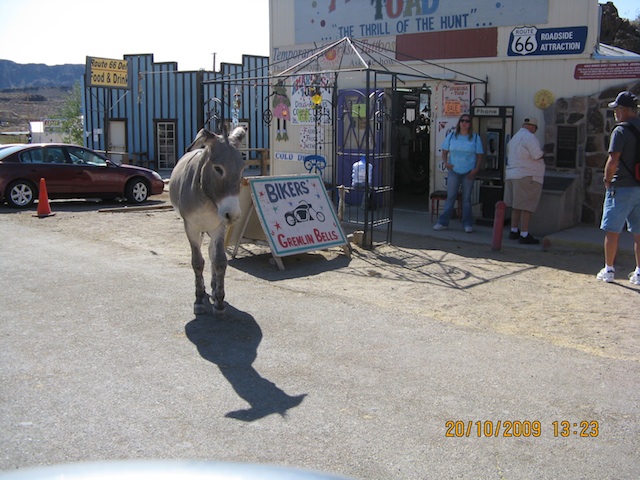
[433,114,483,233]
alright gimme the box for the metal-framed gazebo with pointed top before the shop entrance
[205,37,487,248]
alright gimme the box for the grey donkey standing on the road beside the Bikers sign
[169,127,246,315]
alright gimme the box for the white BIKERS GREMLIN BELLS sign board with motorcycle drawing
[248,175,348,257]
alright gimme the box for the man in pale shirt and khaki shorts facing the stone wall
[504,117,545,245]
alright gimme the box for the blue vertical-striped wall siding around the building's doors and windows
[83,54,269,165]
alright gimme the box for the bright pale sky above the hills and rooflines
[0,0,640,70]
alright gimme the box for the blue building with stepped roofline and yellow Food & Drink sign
[82,54,269,171]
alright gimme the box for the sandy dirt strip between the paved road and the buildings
[5,189,640,361]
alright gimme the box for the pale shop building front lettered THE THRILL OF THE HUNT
[270,0,640,234]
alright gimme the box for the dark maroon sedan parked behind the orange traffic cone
[0,143,164,208]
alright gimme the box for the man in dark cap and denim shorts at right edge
[596,92,640,285]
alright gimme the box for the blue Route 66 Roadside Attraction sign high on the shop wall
[507,27,588,57]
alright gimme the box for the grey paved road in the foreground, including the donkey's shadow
[0,216,640,479]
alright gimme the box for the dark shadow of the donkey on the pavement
[185,305,306,422]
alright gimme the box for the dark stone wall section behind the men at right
[544,82,640,226]
